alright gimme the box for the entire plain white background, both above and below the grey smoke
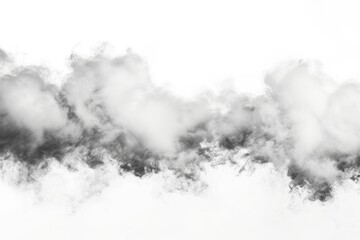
[0,0,360,240]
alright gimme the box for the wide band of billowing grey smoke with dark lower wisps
[0,47,360,201]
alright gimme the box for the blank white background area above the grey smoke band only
[0,0,360,93]
